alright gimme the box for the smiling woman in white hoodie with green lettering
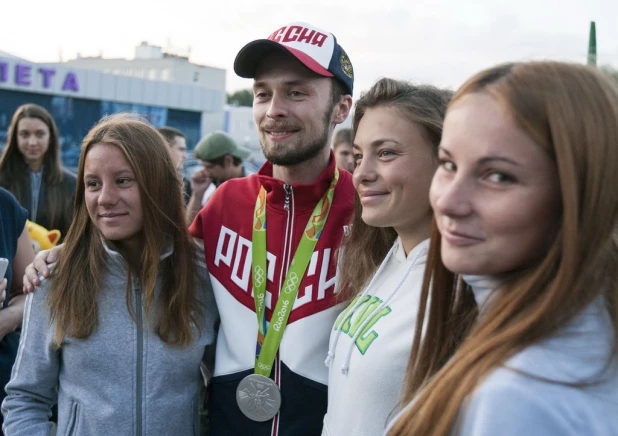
[322,79,450,436]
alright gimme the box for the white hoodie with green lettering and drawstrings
[322,239,429,436]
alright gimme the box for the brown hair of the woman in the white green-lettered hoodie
[338,78,452,300]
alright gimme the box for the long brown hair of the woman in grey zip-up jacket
[48,115,202,346]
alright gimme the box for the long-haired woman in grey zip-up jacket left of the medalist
[2,116,217,436]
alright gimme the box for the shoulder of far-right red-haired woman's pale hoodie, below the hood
[455,358,618,436]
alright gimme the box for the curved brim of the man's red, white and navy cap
[234,39,334,79]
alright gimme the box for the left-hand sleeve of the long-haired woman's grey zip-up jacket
[2,280,60,436]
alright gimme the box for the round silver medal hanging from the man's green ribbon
[236,374,281,422]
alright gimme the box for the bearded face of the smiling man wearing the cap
[253,53,336,166]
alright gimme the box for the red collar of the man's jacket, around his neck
[257,150,341,213]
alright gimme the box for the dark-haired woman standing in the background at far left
[0,104,76,238]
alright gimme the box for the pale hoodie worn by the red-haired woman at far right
[385,276,618,436]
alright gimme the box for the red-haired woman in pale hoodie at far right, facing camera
[387,62,618,436]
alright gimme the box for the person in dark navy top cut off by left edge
[0,188,34,432]
